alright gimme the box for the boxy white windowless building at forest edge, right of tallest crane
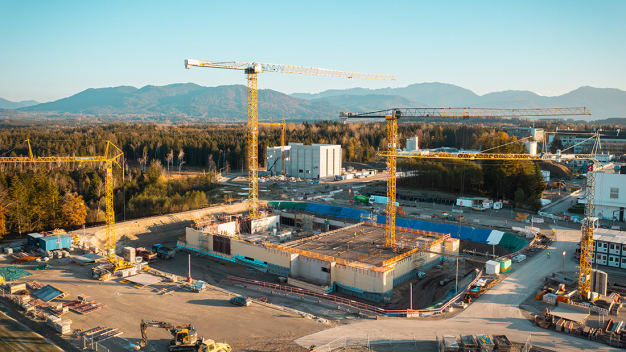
[265,143,341,179]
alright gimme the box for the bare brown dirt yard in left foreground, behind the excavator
[0,253,337,352]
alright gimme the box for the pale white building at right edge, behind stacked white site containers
[595,172,626,221]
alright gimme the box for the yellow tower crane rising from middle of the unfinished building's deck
[340,108,591,247]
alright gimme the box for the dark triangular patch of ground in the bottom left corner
[0,312,63,352]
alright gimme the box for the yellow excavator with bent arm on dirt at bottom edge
[139,319,232,352]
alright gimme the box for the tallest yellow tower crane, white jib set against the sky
[185,60,395,220]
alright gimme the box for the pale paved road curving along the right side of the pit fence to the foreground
[296,228,617,351]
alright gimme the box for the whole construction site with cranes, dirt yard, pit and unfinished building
[0,60,626,352]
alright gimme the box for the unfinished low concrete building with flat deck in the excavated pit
[178,215,459,302]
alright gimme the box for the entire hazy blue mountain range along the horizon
[0,83,626,122]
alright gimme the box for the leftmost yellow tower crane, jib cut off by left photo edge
[0,140,128,270]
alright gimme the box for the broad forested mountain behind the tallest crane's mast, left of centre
[19,83,341,122]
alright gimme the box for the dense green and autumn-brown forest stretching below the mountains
[0,121,536,233]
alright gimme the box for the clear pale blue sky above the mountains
[0,0,626,102]
